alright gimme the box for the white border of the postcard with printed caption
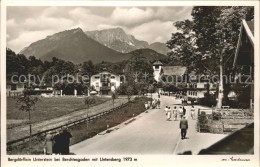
[1,0,260,167]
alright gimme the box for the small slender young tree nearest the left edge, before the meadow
[17,88,39,153]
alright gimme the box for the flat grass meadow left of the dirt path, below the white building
[7,97,111,128]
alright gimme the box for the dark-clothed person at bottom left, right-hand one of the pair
[60,127,72,155]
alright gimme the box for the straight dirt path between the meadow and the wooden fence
[7,98,127,141]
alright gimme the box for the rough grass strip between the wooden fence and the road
[7,97,148,155]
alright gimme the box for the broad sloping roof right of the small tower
[162,66,187,76]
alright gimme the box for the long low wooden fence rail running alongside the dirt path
[7,102,128,146]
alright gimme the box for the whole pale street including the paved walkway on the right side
[70,95,225,154]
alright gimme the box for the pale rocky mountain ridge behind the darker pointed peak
[85,28,169,55]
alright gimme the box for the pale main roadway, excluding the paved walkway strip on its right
[70,96,200,154]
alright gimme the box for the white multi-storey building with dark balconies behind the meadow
[90,71,124,95]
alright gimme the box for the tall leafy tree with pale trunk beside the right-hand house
[192,7,253,108]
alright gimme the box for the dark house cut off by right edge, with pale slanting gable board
[233,20,255,108]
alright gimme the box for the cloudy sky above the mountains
[6,6,192,53]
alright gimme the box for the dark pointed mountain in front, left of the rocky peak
[20,28,128,63]
